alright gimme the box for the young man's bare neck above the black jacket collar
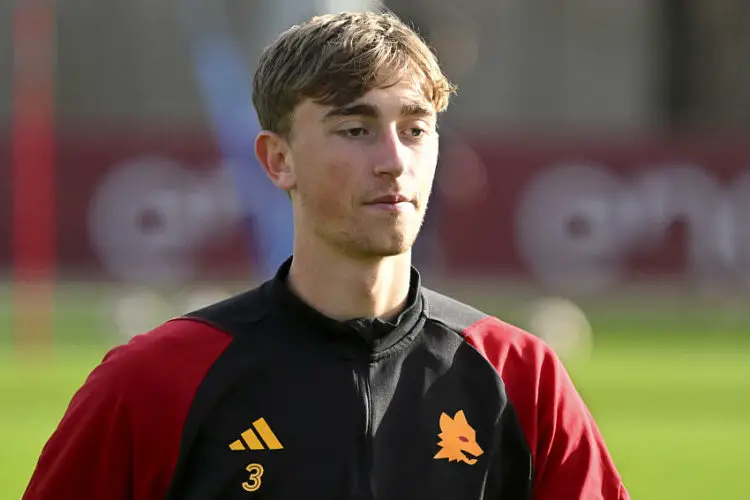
[288,237,418,321]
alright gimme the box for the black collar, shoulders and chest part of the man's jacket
[168,262,532,500]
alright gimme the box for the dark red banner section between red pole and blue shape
[58,127,249,283]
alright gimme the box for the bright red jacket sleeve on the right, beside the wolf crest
[465,318,629,500]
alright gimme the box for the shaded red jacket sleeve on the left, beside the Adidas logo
[23,320,231,500]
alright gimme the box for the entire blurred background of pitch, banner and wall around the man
[0,0,750,500]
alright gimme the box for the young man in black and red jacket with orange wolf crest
[25,9,627,500]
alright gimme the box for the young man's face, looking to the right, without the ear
[287,81,438,258]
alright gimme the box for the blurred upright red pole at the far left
[11,0,56,352]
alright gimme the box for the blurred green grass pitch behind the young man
[0,287,750,500]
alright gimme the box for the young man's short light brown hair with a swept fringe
[253,12,455,135]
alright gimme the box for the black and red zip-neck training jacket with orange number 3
[24,262,628,500]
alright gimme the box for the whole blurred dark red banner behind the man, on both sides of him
[0,130,750,290]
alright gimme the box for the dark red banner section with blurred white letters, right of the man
[442,132,750,290]
